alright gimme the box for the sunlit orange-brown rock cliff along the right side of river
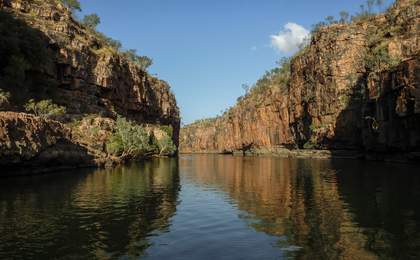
[180,0,420,159]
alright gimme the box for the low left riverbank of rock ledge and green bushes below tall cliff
[0,112,176,176]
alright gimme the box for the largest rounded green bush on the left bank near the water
[106,117,156,157]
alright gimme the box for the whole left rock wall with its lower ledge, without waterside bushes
[0,0,180,171]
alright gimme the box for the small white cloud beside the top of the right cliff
[270,23,310,53]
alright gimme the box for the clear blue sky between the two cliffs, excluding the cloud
[79,0,392,123]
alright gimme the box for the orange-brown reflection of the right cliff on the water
[181,155,420,259]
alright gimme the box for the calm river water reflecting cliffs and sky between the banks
[0,155,420,259]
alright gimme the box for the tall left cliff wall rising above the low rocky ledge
[0,0,180,141]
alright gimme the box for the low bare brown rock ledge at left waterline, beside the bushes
[0,112,96,175]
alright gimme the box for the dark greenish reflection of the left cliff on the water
[0,159,180,259]
